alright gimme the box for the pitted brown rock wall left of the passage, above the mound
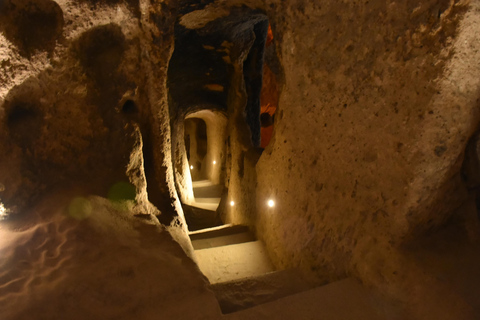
[0,0,186,229]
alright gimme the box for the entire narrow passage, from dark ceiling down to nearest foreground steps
[168,5,406,319]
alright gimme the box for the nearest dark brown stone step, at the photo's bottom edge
[223,278,388,320]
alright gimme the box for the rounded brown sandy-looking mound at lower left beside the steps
[0,197,220,320]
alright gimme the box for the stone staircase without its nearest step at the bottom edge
[184,172,304,313]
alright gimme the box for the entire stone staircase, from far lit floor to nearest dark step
[186,181,390,320]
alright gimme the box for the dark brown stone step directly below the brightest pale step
[210,269,315,314]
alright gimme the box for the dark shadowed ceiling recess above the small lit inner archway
[167,5,268,141]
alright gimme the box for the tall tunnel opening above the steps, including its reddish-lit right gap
[167,5,281,238]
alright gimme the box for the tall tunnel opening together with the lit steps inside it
[167,4,296,312]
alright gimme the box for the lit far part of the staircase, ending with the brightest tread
[189,180,275,284]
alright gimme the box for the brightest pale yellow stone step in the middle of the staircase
[195,240,275,284]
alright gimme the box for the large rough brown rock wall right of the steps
[257,1,480,319]
